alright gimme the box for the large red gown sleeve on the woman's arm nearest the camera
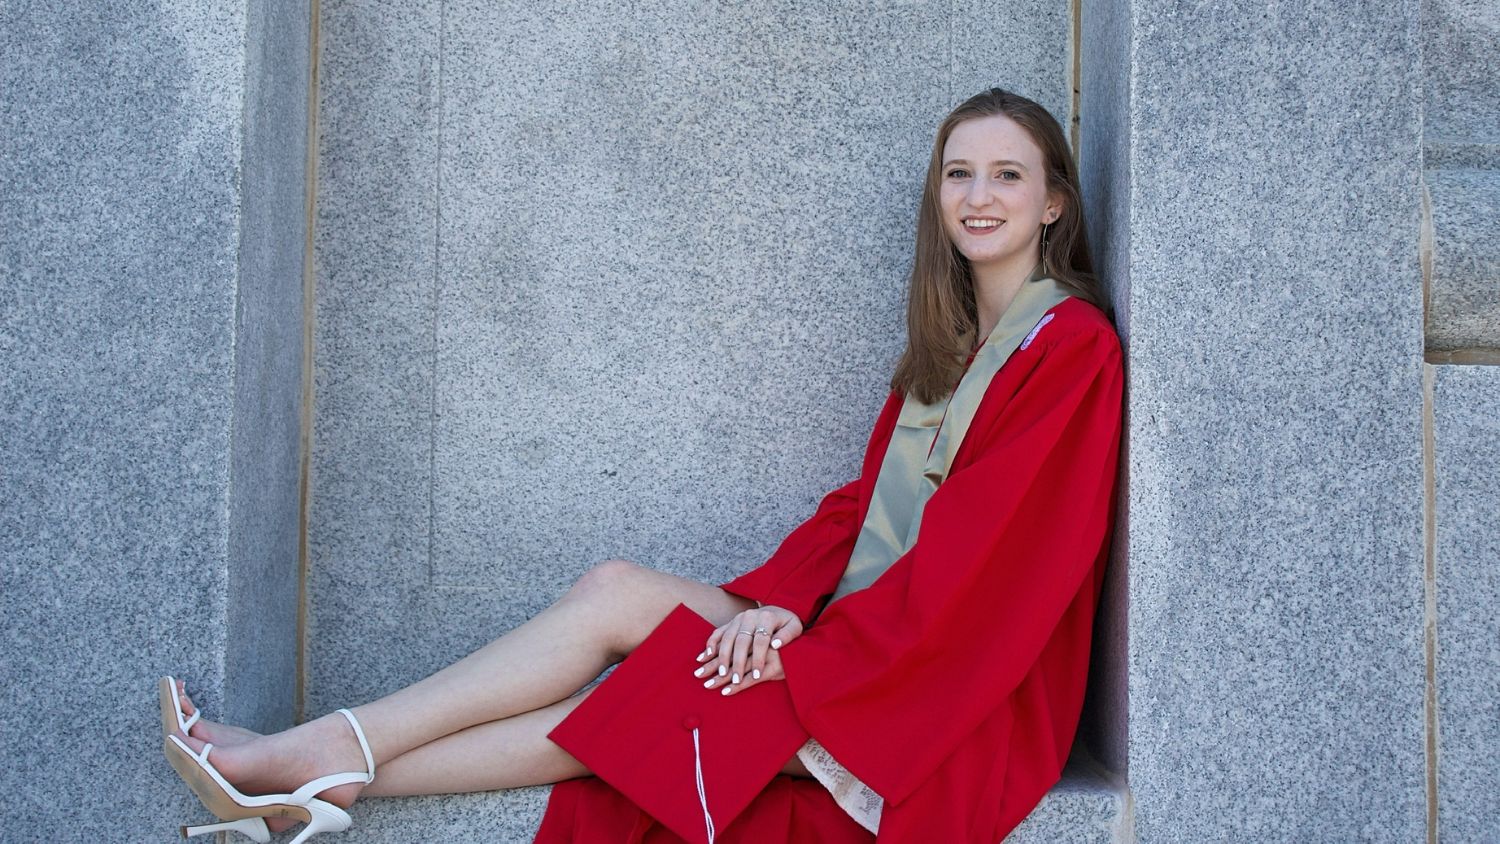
[780,327,1124,804]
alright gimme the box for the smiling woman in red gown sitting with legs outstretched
[162,88,1122,844]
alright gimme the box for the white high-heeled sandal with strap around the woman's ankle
[165,709,375,844]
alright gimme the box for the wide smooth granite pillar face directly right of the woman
[1122,0,1427,841]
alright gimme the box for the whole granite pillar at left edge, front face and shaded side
[0,0,306,841]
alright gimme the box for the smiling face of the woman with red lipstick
[939,114,1062,279]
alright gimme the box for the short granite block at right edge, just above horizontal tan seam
[1424,169,1500,351]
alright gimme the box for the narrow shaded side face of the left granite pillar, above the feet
[224,0,312,732]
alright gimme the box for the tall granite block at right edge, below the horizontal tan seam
[1433,366,1500,843]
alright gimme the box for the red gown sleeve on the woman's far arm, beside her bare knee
[719,394,902,628]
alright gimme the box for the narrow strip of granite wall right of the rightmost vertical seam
[1422,0,1500,841]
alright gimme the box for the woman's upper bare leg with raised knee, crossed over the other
[172,561,755,807]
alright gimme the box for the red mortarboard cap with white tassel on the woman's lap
[548,604,809,844]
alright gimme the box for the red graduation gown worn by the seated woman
[536,298,1124,844]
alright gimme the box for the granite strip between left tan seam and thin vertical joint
[305,0,441,717]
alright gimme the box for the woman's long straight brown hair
[891,88,1109,402]
